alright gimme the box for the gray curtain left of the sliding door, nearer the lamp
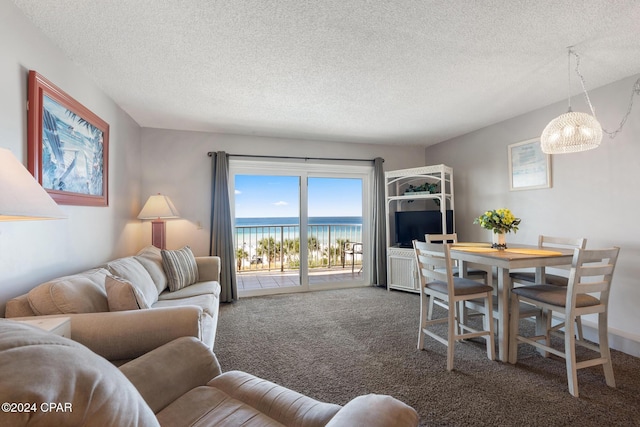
[209,151,238,302]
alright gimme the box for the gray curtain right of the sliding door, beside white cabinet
[371,157,387,287]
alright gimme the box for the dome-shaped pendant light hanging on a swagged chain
[540,47,640,154]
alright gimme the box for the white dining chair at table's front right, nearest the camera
[509,247,620,397]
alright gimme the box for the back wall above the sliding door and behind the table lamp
[140,128,424,255]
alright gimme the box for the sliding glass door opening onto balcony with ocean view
[230,159,372,296]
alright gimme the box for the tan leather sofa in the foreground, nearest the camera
[0,319,418,427]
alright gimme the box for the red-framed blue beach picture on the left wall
[27,71,109,206]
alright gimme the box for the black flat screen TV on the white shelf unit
[395,210,453,248]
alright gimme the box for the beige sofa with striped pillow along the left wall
[5,246,220,364]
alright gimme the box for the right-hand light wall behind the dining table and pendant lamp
[426,76,640,356]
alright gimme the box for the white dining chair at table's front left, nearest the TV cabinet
[413,240,495,371]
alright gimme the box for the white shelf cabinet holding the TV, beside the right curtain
[385,165,455,292]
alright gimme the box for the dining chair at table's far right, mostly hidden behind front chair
[509,235,587,339]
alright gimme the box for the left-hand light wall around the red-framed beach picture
[0,0,141,315]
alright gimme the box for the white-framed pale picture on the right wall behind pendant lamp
[508,138,551,191]
